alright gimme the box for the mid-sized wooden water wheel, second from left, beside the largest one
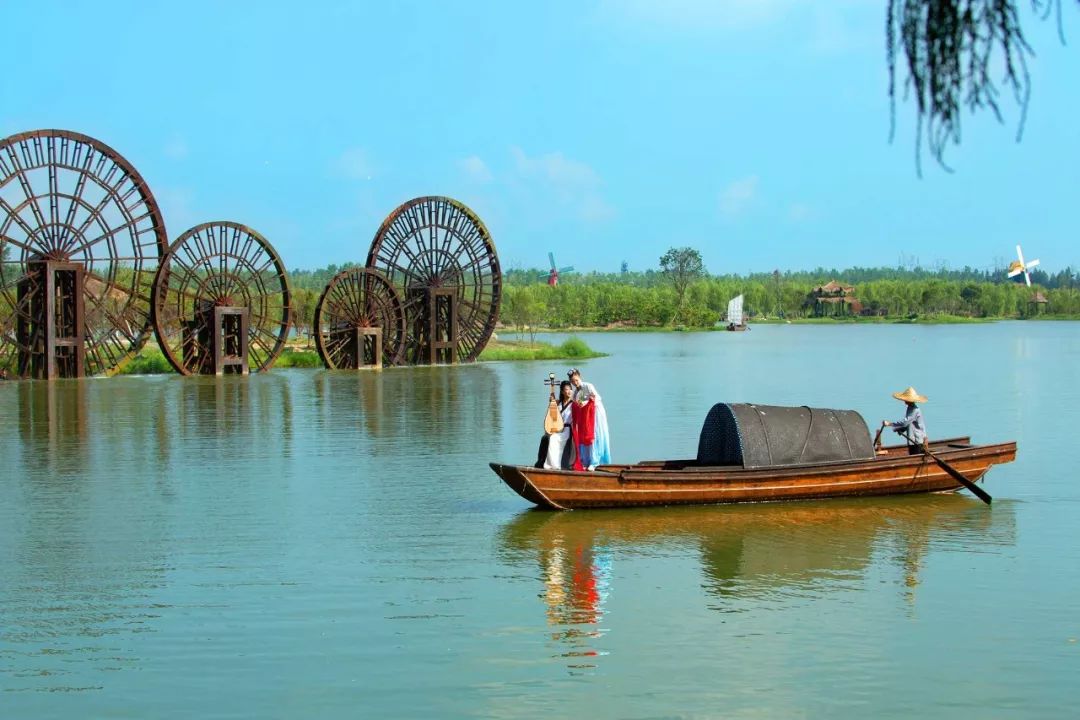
[153,221,291,375]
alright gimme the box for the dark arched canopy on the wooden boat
[698,403,875,470]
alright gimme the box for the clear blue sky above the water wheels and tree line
[0,0,1080,273]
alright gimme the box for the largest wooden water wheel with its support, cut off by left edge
[0,130,168,378]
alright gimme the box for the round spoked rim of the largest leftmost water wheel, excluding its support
[0,130,168,377]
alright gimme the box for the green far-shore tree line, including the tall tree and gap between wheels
[280,262,1080,337]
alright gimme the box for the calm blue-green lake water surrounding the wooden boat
[0,322,1080,719]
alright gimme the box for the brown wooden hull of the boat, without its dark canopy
[490,438,1016,510]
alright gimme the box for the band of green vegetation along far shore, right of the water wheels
[488,271,1080,332]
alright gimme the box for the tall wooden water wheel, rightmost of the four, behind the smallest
[367,196,502,365]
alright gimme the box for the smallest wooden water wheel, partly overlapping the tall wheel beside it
[314,268,406,369]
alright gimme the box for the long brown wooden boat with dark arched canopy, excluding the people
[490,404,1016,510]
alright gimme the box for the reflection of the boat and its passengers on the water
[500,495,1015,669]
